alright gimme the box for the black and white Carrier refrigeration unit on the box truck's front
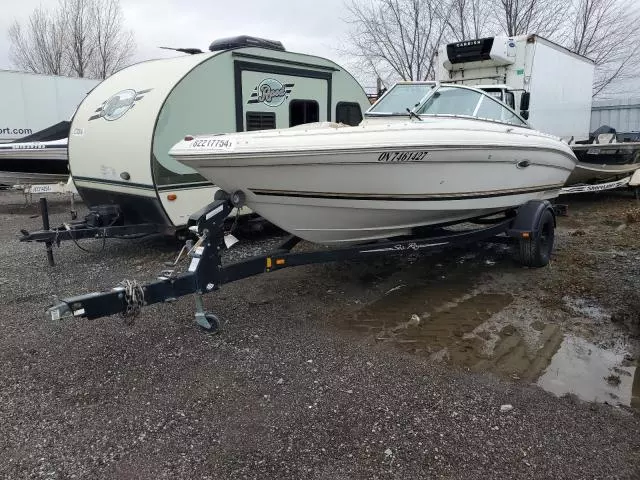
[443,37,516,70]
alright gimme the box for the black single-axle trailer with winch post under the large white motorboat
[43,199,555,332]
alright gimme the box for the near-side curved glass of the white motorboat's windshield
[416,86,528,127]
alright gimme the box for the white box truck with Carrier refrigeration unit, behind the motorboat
[436,35,595,141]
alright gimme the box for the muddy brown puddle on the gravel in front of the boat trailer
[340,282,640,408]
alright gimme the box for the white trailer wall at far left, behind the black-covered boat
[0,70,100,142]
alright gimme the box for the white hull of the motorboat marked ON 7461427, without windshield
[171,120,575,245]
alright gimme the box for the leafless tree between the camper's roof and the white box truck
[344,0,451,84]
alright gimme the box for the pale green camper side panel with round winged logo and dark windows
[236,62,331,131]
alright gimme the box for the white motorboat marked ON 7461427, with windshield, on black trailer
[169,82,576,245]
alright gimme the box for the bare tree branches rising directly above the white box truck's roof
[490,0,569,39]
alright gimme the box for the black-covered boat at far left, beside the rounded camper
[0,121,70,186]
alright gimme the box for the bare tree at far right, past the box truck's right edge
[564,0,640,96]
